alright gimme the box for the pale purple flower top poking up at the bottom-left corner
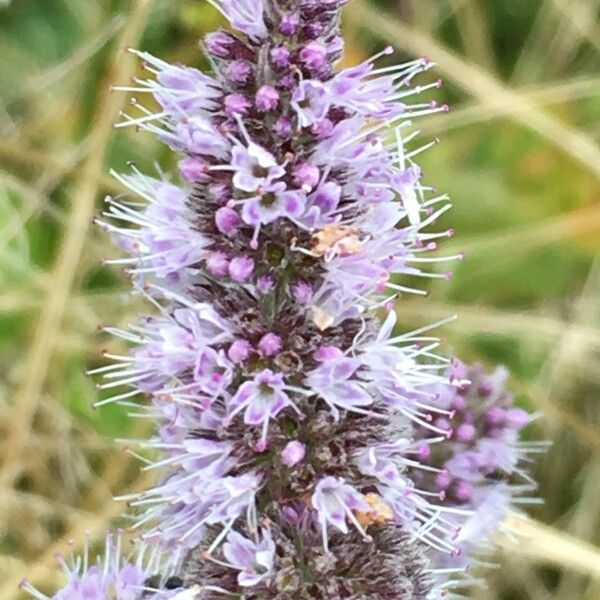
[20,532,184,600]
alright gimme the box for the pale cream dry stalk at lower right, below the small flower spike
[499,514,600,579]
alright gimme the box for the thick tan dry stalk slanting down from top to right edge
[347,2,600,178]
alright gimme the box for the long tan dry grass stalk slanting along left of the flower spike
[0,0,153,487]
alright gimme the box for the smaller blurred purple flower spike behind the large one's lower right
[412,360,545,565]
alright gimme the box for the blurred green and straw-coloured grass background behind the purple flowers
[0,0,600,600]
